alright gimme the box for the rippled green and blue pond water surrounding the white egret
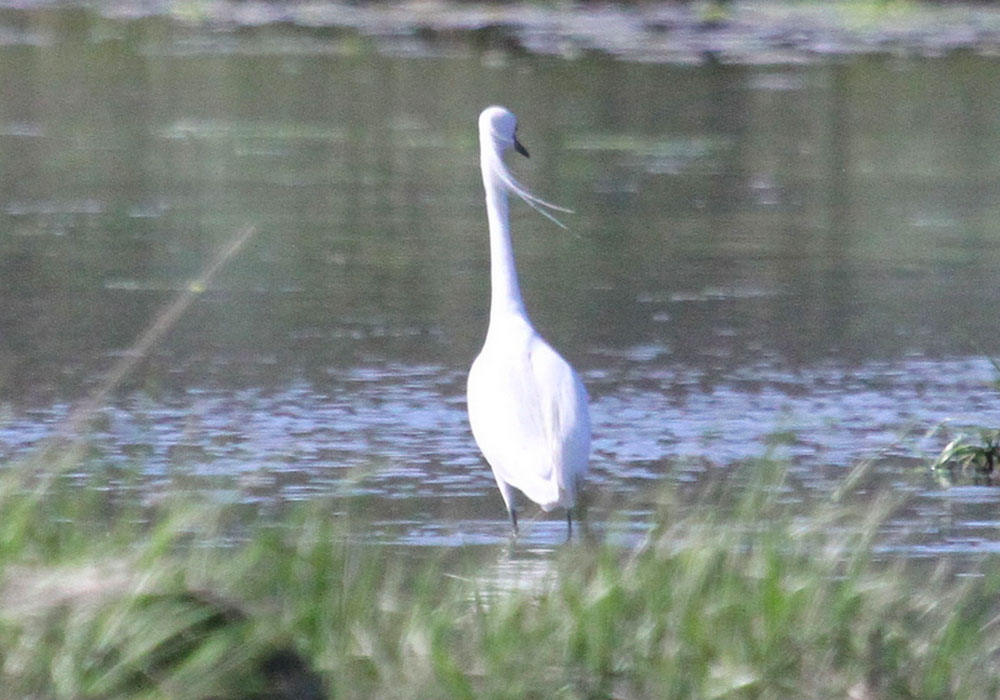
[0,10,1000,556]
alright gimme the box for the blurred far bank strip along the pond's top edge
[15,0,1000,64]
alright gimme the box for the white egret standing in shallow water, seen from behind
[468,106,590,536]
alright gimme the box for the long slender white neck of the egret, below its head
[481,151,527,325]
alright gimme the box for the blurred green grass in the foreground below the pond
[0,463,1000,699]
